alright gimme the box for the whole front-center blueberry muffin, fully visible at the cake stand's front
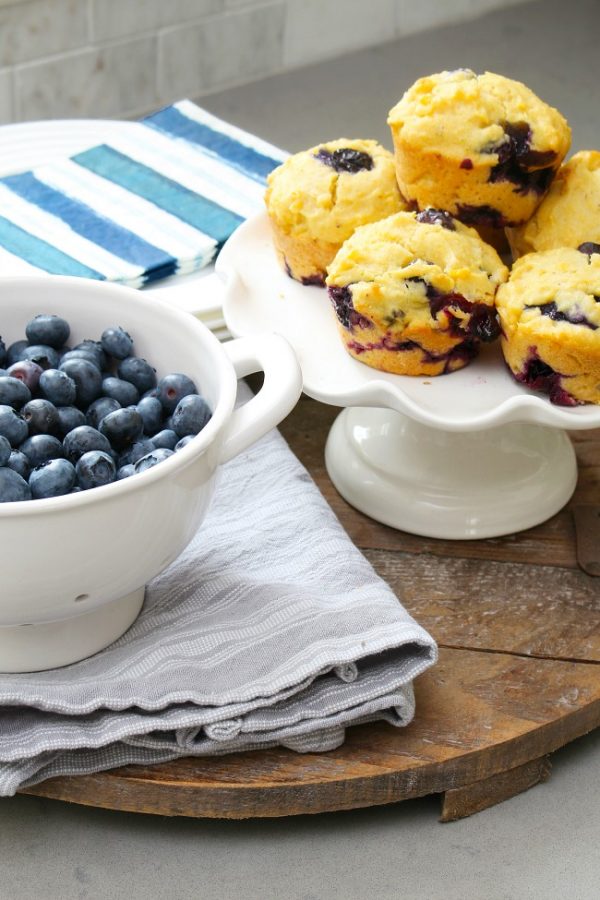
[327,209,508,375]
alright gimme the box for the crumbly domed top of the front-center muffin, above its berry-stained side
[326,209,508,336]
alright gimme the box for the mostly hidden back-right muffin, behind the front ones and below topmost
[507,150,600,258]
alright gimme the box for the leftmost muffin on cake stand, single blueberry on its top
[265,138,407,285]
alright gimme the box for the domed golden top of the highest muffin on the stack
[388,69,571,170]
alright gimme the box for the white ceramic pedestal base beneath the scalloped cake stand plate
[325,407,577,540]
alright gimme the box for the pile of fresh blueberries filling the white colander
[0,314,211,503]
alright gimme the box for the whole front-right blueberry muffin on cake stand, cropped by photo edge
[496,248,600,406]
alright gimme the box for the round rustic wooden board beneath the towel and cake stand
[24,397,600,821]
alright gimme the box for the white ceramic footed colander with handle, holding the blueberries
[0,276,302,672]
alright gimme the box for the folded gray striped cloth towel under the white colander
[0,386,437,795]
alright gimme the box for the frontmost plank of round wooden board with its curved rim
[25,650,600,819]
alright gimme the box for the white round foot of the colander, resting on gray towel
[0,587,145,673]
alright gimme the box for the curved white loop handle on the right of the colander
[220,334,302,463]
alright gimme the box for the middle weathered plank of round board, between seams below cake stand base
[365,550,600,660]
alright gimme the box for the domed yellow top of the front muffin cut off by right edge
[496,247,600,338]
